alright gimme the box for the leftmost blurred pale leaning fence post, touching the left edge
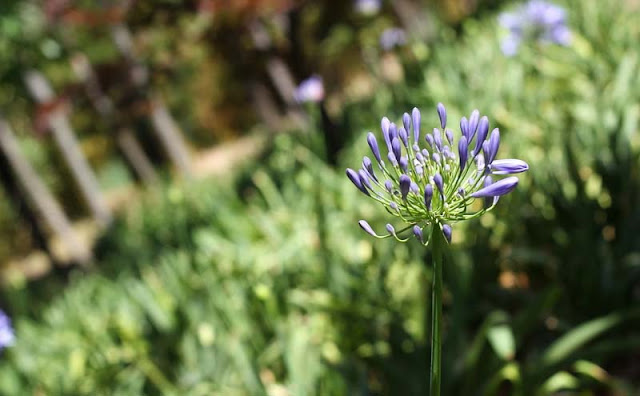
[0,116,91,265]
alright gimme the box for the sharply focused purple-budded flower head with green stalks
[347,103,529,245]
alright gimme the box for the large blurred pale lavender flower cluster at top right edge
[498,0,571,56]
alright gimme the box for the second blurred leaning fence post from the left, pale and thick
[24,71,112,227]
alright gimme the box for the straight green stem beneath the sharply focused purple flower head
[430,224,446,396]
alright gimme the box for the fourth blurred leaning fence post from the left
[111,23,191,176]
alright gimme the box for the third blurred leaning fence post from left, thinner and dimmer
[71,53,158,185]
